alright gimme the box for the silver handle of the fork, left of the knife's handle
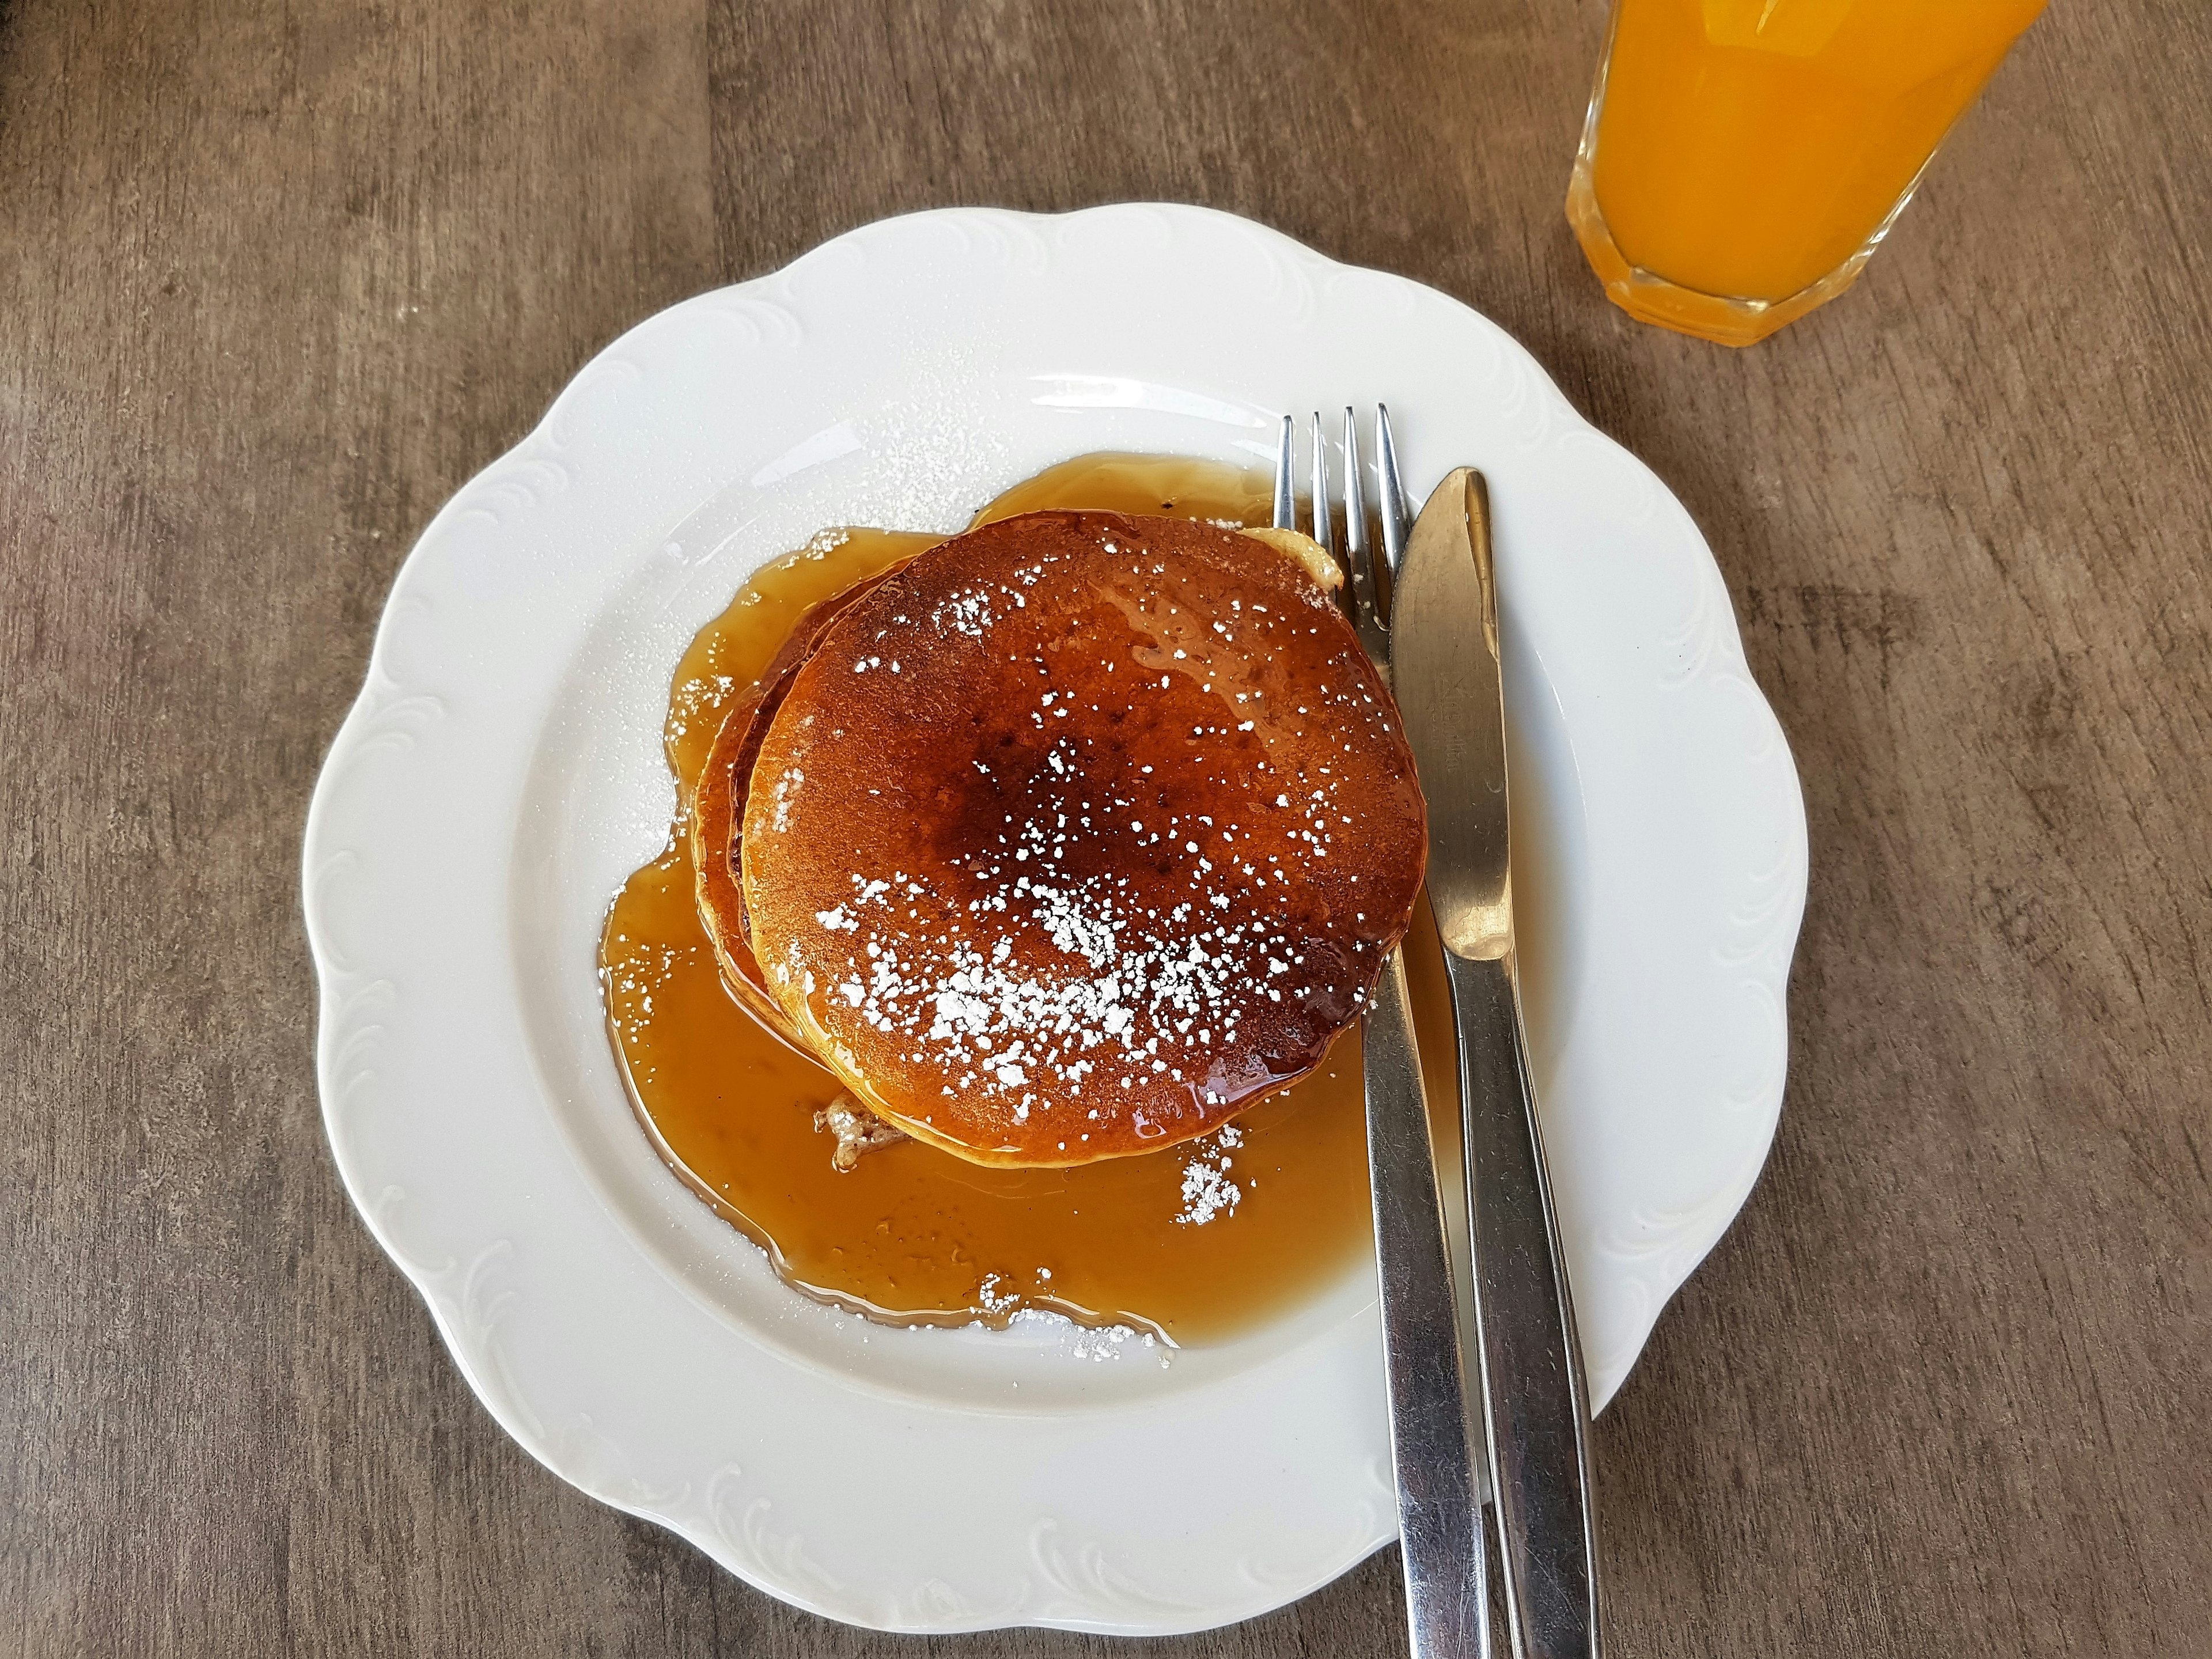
[1361,951,1491,1659]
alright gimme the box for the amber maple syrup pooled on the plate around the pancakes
[600,456,1458,1345]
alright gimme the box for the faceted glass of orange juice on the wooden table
[1566,0,2044,345]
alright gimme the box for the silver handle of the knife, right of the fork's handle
[1445,951,1599,1659]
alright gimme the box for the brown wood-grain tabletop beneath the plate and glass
[0,0,2212,1659]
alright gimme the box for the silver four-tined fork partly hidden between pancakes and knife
[1274,405,1491,1659]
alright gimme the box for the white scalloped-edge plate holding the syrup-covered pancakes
[305,206,1805,1635]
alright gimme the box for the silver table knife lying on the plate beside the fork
[1391,467,1599,1659]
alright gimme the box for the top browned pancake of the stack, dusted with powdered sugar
[739,511,1427,1166]
